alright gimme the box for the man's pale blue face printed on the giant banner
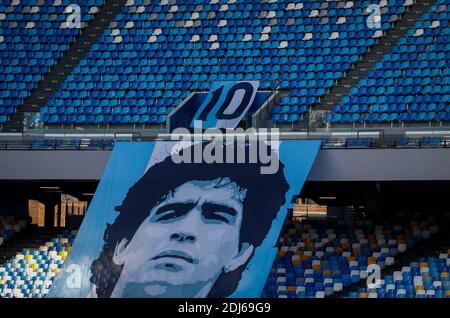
[114,178,253,296]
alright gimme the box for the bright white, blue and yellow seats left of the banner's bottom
[0,231,76,298]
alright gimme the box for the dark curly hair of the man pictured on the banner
[90,145,289,298]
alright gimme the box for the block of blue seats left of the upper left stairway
[0,0,104,123]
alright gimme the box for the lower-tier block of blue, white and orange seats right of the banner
[262,217,438,298]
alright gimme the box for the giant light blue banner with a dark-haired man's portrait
[48,140,320,298]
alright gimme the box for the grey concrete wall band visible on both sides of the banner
[0,148,450,181]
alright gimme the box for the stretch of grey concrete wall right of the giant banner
[308,148,450,181]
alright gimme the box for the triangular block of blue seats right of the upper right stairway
[328,0,450,124]
